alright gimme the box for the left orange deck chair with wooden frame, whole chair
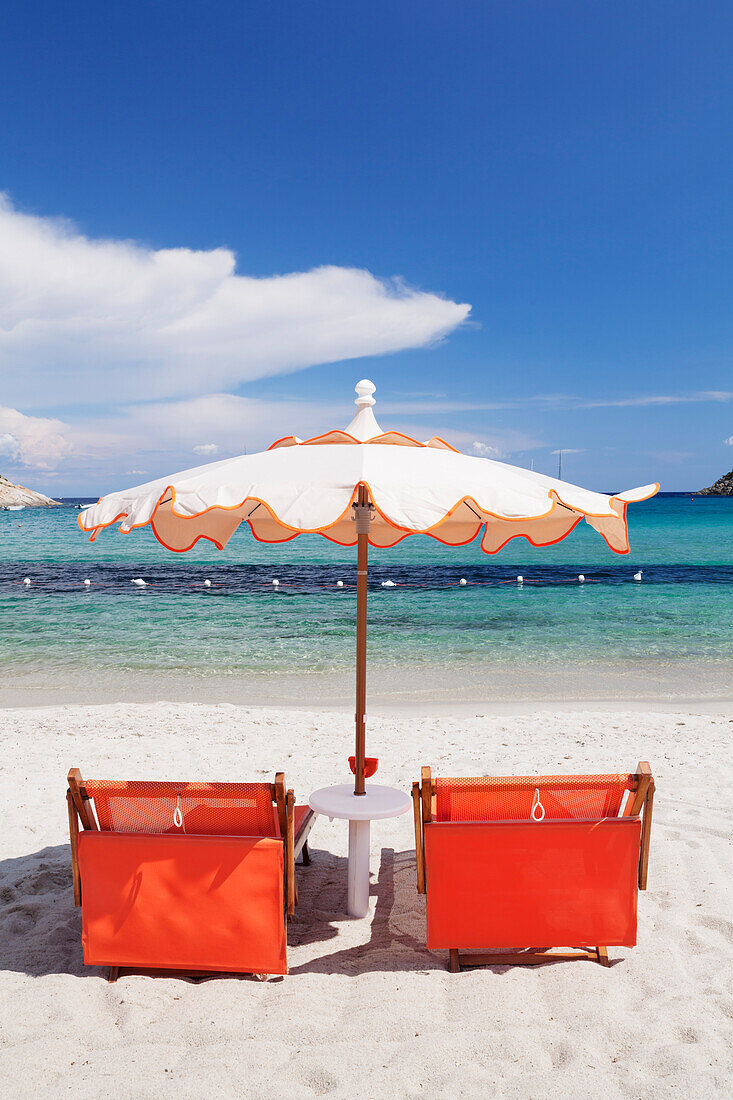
[66,768,314,981]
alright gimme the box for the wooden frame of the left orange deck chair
[66,768,316,981]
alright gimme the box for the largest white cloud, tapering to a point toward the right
[0,194,470,407]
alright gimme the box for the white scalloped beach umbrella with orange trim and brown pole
[78,381,659,794]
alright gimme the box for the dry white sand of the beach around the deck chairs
[0,703,733,1100]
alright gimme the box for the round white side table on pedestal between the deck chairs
[308,783,412,916]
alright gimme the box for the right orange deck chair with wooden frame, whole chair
[413,762,654,971]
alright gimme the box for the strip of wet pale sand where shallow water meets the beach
[0,660,733,714]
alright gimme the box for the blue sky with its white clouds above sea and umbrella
[0,0,733,495]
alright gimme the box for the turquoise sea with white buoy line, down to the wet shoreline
[0,494,733,704]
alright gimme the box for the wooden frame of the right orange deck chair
[413,760,655,974]
